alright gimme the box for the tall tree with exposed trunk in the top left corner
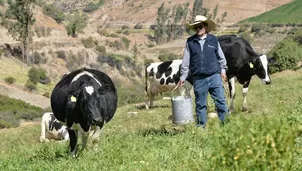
[5,0,36,63]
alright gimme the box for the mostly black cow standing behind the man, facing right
[218,35,271,112]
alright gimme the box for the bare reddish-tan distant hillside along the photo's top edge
[85,0,292,27]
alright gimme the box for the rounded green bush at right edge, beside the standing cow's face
[269,38,302,73]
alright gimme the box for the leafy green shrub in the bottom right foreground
[205,116,299,170]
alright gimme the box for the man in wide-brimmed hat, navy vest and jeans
[179,15,228,128]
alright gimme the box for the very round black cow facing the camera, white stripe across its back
[51,68,117,156]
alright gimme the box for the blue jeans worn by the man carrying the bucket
[194,74,228,127]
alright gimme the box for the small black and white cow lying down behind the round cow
[40,112,69,142]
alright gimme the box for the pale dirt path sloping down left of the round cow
[0,81,50,109]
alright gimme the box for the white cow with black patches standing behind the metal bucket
[145,60,193,109]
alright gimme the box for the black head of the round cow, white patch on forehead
[79,85,103,125]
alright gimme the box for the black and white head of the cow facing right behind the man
[249,55,271,84]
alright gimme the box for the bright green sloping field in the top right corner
[239,0,302,24]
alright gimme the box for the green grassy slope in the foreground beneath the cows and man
[0,70,302,171]
